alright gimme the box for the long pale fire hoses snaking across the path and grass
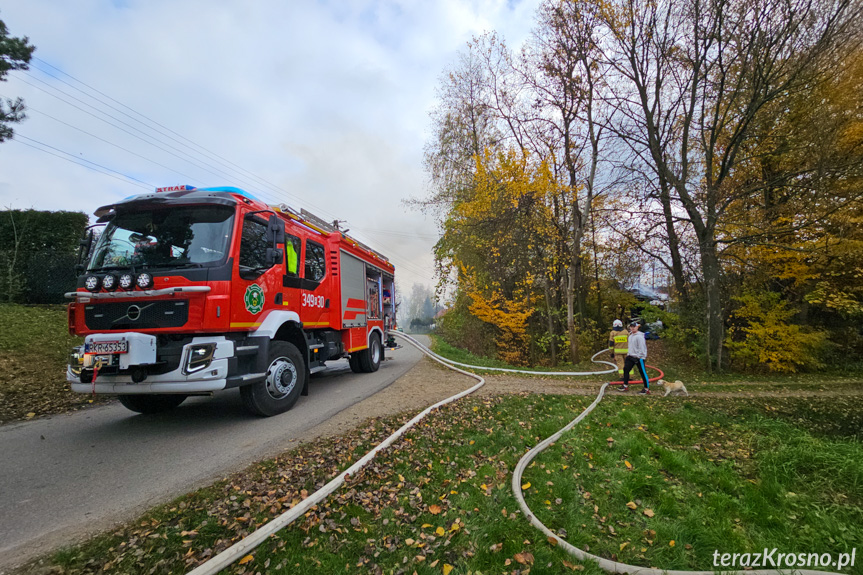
[188,332,843,575]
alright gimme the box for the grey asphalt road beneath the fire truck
[0,345,421,573]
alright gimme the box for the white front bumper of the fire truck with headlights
[66,332,235,394]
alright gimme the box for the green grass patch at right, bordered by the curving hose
[525,398,863,572]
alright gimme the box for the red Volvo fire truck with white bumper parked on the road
[66,186,396,416]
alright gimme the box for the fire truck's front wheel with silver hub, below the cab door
[240,340,306,417]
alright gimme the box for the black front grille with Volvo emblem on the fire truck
[84,300,189,330]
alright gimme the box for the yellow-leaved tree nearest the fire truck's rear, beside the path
[435,149,560,365]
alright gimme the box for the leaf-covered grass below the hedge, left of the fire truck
[0,304,104,423]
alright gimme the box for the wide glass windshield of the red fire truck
[87,206,234,271]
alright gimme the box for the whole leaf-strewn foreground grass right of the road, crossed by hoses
[27,395,863,575]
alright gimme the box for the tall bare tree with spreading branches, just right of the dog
[603,0,860,368]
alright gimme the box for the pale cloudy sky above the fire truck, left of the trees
[0,0,538,293]
